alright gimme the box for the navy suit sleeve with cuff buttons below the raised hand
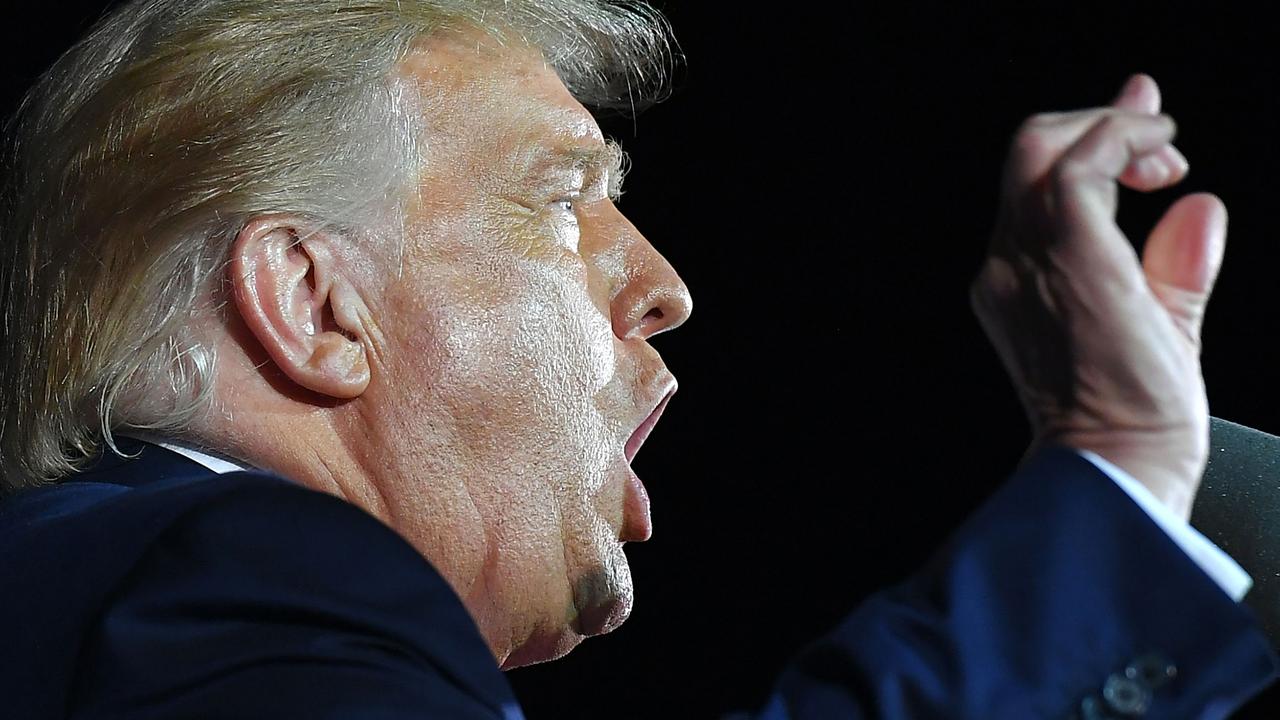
[756,448,1276,720]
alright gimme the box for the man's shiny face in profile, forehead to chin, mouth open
[357,30,690,666]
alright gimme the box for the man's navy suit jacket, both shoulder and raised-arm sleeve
[0,446,1276,720]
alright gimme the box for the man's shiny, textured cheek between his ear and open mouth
[388,252,625,520]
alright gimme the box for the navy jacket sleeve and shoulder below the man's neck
[68,478,520,720]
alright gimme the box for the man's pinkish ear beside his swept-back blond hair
[229,215,370,400]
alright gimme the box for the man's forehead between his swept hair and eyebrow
[399,32,603,163]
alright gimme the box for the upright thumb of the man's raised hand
[1142,193,1226,345]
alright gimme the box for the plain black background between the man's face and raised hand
[10,0,1280,719]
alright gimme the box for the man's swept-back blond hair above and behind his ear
[0,0,675,492]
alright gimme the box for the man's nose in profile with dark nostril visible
[609,230,694,340]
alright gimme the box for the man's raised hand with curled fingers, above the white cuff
[972,76,1226,518]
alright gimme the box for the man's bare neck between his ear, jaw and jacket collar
[192,313,496,661]
